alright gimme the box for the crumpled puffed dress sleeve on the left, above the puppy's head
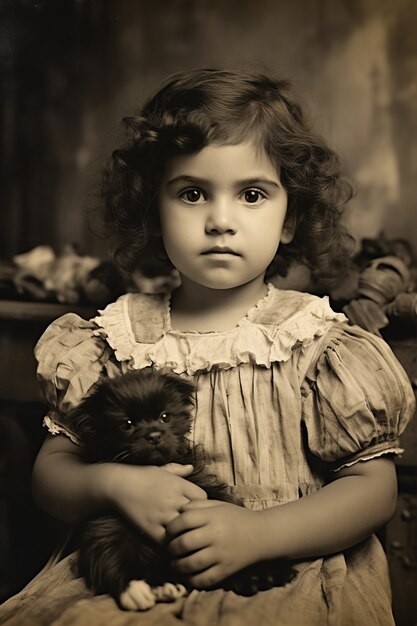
[35,313,117,443]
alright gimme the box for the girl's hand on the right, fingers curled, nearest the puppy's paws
[167,500,260,588]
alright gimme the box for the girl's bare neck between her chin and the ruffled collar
[171,277,267,332]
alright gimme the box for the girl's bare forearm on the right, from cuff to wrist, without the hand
[255,457,397,558]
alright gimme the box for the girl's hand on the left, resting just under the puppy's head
[102,463,207,543]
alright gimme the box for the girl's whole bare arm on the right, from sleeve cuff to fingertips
[167,457,397,587]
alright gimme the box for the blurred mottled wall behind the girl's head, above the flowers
[0,0,417,258]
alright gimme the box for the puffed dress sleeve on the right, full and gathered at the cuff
[302,323,415,470]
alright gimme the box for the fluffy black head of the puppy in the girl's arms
[68,369,194,465]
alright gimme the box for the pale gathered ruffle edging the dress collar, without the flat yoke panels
[94,286,346,375]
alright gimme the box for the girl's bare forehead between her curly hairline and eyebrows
[163,141,279,182]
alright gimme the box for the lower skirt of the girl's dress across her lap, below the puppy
[0,537,394,626]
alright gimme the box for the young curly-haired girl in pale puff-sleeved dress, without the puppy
[0,70,413,626]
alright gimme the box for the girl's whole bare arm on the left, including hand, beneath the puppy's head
[32,436,207,541]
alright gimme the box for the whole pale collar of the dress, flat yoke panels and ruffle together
[93,284,346,375]
